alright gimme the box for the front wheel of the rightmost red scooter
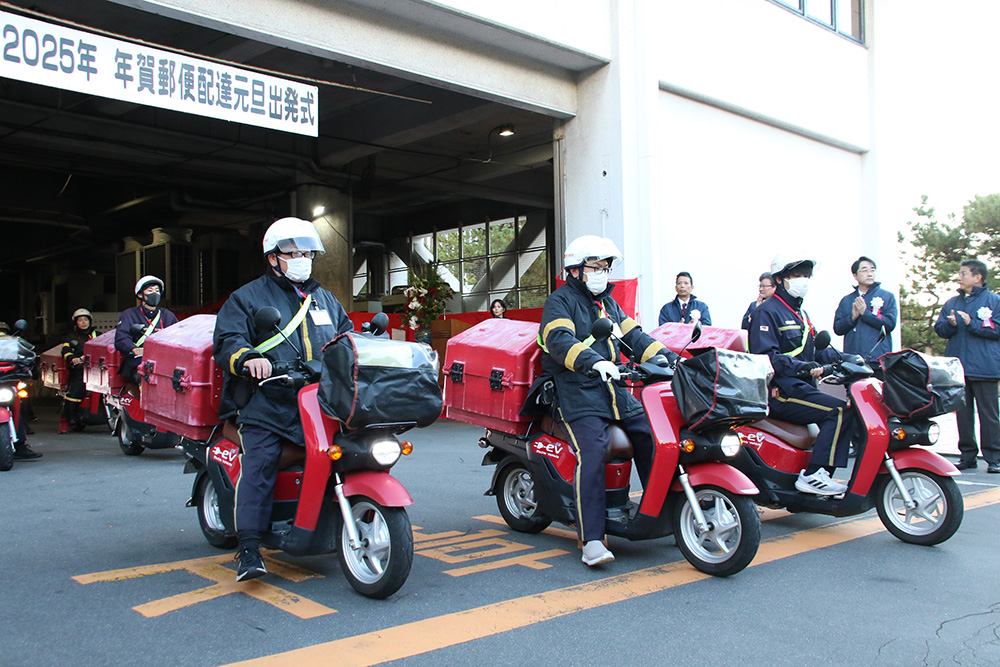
[875,470,965,546]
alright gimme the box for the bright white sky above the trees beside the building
[872,0,1000,225]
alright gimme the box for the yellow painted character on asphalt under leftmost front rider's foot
[73,551,337,619]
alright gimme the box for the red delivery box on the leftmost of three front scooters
[139,315,222,440]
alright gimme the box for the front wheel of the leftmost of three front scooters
[338,496,413,600]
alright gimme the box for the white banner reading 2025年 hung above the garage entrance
[0,12,319,137]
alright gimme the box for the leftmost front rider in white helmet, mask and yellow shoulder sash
[212,218,354,581]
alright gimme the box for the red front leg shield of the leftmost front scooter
[295,384,336,530]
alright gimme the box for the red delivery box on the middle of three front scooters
[443,319,542,433]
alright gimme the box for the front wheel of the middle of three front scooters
[674,487,760,577]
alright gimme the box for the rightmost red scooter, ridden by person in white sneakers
[732,332,964,545]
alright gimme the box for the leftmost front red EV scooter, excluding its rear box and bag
[181,308,416,599]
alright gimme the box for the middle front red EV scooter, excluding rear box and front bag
[479,319,760,577]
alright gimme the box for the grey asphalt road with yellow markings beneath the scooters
[0,406,1000,667]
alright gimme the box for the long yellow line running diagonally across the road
[225,489,1000,667]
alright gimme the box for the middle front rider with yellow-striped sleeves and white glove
[538,236,673,566]
